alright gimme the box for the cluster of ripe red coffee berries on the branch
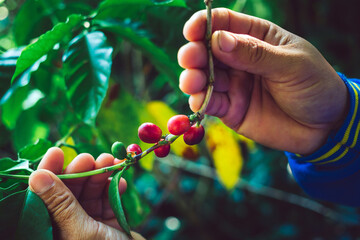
[138,115,204,157]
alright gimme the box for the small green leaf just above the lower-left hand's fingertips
[18,139,52,161]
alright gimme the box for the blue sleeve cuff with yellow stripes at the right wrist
[285,74,360,206]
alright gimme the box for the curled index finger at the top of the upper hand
[183,8,280,41]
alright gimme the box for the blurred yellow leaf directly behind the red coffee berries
[146,101,199,159]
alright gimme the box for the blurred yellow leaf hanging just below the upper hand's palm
[205,121,243,190]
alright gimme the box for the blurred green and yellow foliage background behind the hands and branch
[0,0,360,240]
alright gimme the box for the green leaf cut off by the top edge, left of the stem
[95,0,187,19]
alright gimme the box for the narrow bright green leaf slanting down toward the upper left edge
[11,14,83,82]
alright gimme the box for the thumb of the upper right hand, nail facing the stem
[211,31,289,76]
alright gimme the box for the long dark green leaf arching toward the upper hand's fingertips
[94,21,182,94]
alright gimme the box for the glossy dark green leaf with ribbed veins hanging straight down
[64,32,113,125]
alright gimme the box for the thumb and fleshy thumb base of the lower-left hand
[29,169,139,240]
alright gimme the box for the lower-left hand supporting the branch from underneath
[29,147,144,240]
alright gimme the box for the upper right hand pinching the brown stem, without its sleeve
[178,8,348,154]
